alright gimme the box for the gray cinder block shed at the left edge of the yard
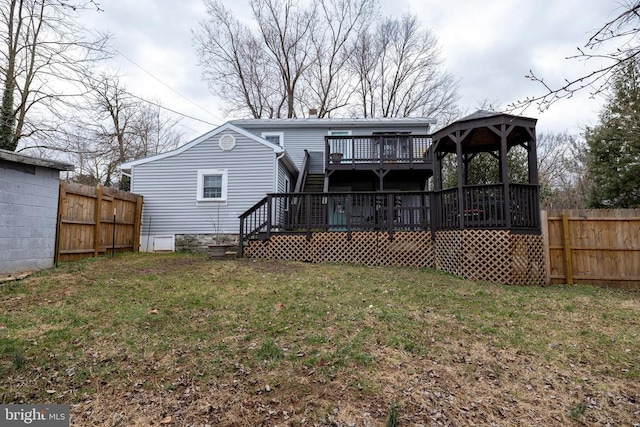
[0,150,73,274]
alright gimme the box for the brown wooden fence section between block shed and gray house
[55,181,142,262]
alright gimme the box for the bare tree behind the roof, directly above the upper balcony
[351,15,458,121]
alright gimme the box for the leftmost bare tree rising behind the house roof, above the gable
[194,0,315,118]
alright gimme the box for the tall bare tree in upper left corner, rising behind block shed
[0,0,108,151]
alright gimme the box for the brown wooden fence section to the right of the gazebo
[542,209,640,289]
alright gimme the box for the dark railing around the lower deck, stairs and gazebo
[240,184,540,253]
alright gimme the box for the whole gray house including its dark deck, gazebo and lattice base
[122,111,545,284]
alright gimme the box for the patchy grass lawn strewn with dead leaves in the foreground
[0,254,640,426]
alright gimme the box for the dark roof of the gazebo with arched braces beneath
[432,110,538,153]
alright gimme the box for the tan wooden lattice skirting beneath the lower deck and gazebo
[244,230,545,285]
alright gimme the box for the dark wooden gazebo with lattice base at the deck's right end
[431,110,545,284]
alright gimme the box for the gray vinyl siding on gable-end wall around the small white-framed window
[132,131,276,235]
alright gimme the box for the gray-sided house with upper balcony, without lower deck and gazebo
[121,118,434,251]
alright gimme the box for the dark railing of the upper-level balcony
[325,134,431,168]
